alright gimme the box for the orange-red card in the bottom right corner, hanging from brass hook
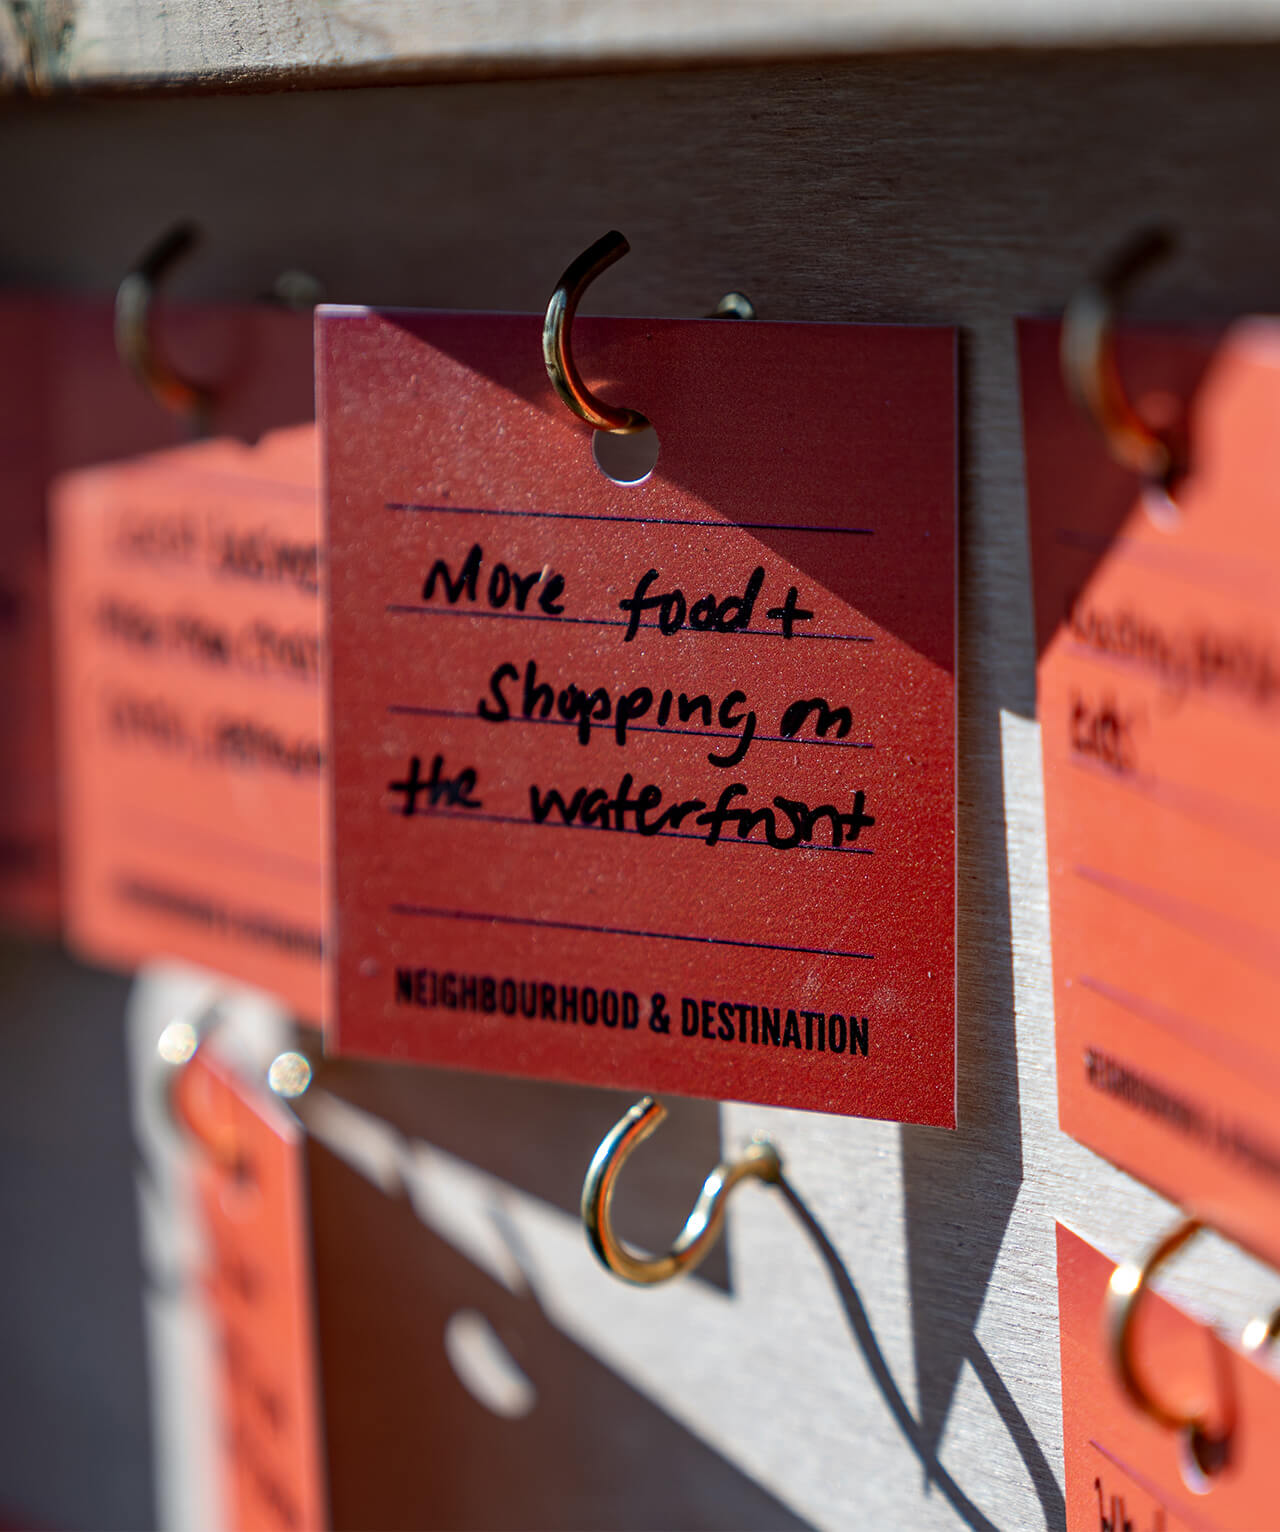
[1058,1224,1280,1532]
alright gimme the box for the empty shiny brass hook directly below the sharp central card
[582,1095,782,1287]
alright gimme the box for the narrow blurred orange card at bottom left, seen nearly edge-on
[178,1052,328,1532]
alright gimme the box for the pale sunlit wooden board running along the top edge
[0,0,1280,93]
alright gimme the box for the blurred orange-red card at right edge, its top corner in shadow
[1020,320,1280,1261]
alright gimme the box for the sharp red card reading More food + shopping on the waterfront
[317,309,955,1124]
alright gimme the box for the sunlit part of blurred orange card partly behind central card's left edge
[54,426,325,1017]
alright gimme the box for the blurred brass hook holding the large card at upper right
[1061,228,1185,490]
